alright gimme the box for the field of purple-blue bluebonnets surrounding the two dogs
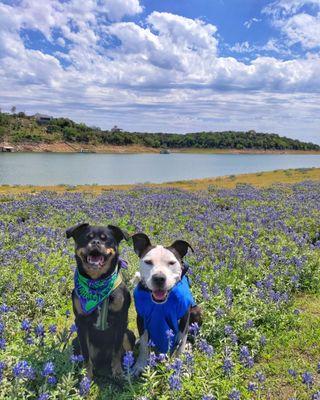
[0,182,320,400]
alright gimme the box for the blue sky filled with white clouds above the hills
[0,0,320,143]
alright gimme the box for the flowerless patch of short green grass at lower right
[251,294,320,400]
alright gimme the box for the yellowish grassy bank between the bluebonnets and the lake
[0,168,320,194]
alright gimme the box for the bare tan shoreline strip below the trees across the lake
[5,142,320,154]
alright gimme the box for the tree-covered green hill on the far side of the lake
[0,110,320,151]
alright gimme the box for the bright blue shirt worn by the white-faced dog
[134,276,195,353]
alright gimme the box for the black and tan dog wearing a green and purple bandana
[66,223,135,378]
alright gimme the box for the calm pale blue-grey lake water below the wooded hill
[0,153,320,185]
